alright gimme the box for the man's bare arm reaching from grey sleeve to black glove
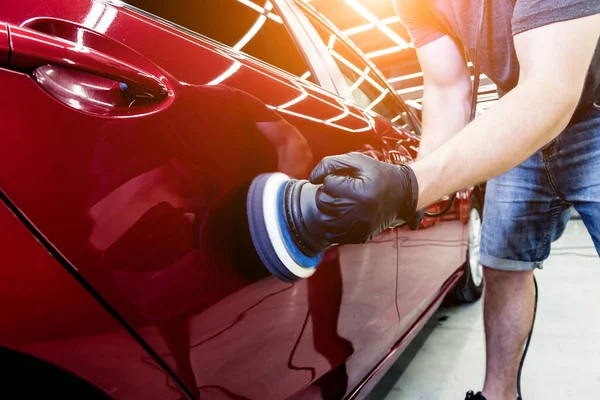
[411,14,600,207]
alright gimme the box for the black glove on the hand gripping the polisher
[310,153,419,244]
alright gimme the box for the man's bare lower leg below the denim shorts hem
[483,267,534,400]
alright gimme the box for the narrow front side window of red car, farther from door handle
[300,13,410,128]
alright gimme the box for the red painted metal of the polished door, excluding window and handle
[0,1,412,399]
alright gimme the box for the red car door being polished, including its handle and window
[0,0,399,399]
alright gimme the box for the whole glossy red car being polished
[0,0,482,400]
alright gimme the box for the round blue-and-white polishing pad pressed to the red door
[246,172,316,282]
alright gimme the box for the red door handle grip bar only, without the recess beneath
[6,18,169,100]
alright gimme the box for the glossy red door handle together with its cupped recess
[5,18,173,116]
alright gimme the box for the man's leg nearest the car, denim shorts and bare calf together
[474,142,570,400]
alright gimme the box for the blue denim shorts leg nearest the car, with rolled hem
[480,151,570,271]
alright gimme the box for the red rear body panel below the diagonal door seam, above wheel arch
[0,198,188,400]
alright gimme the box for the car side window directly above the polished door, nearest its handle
[125,0,314,82]
